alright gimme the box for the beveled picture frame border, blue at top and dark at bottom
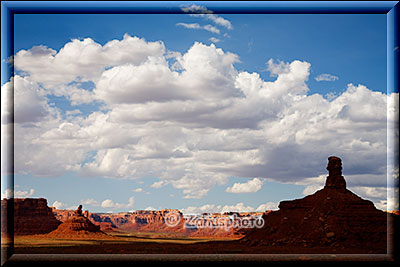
[1,1,399,265]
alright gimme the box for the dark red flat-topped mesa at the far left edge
[1,198,61,235]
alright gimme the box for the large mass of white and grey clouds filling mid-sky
[7,35,398,207]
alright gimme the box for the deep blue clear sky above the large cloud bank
[14,14,386,93]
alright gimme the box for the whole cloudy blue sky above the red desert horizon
[1,4,398,213]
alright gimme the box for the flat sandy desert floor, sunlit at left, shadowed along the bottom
[10,233,387,254]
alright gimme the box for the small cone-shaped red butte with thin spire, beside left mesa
[46,205,107,239]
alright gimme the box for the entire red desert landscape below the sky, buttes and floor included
[1,157,398,254]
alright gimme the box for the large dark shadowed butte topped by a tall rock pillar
[241,157,387,253]
